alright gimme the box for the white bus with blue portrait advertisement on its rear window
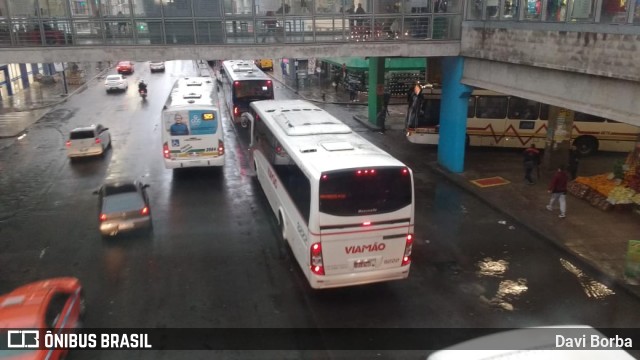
[160,77,224,169]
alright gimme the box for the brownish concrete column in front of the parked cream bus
[543,106,575,171]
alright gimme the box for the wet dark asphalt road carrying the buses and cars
[0,61,640,359]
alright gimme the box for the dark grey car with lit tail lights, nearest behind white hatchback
[94,180,152,236]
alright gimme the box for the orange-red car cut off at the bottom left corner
[0,277,85,360]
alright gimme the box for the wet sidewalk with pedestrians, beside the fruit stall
[272,67,640,297]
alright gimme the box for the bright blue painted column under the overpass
[438,56,472,173]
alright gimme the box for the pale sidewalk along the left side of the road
[0,63,109,149]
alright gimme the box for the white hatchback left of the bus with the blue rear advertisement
[66,124,111,158]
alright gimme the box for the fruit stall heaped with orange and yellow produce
[567,150,640,211]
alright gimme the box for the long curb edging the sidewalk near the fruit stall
[427,162,640,298]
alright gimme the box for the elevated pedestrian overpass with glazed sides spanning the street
[0,0,640,172]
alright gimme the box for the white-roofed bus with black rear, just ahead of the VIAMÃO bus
[220,60,274,127]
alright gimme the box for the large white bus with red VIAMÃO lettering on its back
[245,100,414,289]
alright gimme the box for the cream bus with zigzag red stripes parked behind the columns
[406,89,640,155]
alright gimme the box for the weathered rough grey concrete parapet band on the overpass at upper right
[461,26,640,81]
